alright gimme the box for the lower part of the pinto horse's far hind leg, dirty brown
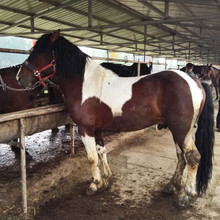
[163,144,186,194]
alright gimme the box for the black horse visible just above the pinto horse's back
[101,62,152,77]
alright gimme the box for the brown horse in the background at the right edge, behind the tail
[202,65,220,100]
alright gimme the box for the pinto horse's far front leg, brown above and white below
[95,130,112,178]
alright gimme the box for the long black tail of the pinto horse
[195,83,214,195]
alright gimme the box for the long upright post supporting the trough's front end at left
[20,118,27,214]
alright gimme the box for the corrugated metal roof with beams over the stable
[0,0,220,64]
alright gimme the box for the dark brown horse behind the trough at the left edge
[0,64,63,153]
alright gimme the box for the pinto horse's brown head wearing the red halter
[16,31,60,87]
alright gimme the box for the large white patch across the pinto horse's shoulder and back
[81,59,144,116]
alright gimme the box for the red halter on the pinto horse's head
[25,56,56,87]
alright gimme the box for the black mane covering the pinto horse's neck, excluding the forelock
[53,36,89,79]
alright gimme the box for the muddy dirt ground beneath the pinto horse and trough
[0,103,220,220]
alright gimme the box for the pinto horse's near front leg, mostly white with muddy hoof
[79,128,103,195]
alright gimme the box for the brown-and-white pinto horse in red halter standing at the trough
[17,31,214,208]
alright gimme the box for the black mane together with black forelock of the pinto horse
[32,34,88,79]
